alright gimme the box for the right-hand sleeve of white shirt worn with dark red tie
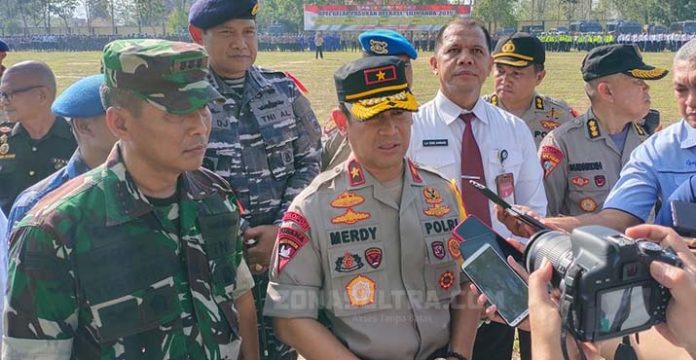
[515,123,546,216]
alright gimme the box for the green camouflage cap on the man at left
[102,39,224,115]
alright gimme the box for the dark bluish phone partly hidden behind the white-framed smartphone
[452,215,524,263]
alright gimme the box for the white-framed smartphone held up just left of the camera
[462,244,529,326]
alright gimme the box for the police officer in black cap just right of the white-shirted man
[484,32,576,148]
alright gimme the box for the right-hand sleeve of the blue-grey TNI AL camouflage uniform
[276,93,321,223]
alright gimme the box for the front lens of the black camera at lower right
[524,231,573,287]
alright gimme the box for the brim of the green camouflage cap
[144,80,225,115]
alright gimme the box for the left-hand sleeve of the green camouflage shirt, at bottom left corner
[2,227,78,360]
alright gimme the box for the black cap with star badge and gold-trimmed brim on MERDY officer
[334,56,418,121]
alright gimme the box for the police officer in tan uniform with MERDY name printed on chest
[264,56,480,360]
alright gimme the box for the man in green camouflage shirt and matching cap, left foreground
[2,39,258,360]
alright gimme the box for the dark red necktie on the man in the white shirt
[459,113,491,226]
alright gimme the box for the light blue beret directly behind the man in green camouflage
[51,74,106,118]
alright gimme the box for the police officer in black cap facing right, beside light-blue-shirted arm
[539,44,668,216]
